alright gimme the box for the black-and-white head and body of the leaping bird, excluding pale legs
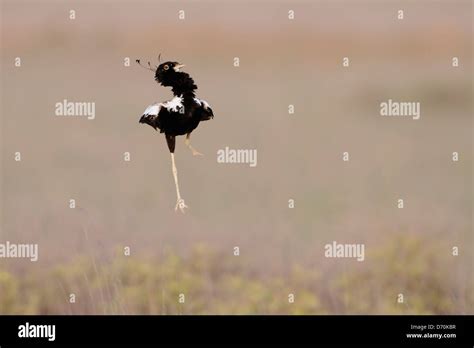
[140,62,214,152]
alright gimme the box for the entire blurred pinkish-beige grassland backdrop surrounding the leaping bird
[0,0,474,314]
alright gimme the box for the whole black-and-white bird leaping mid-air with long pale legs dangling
[136,54,214,213]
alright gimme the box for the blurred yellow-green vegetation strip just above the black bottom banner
[0,236,473,314]
